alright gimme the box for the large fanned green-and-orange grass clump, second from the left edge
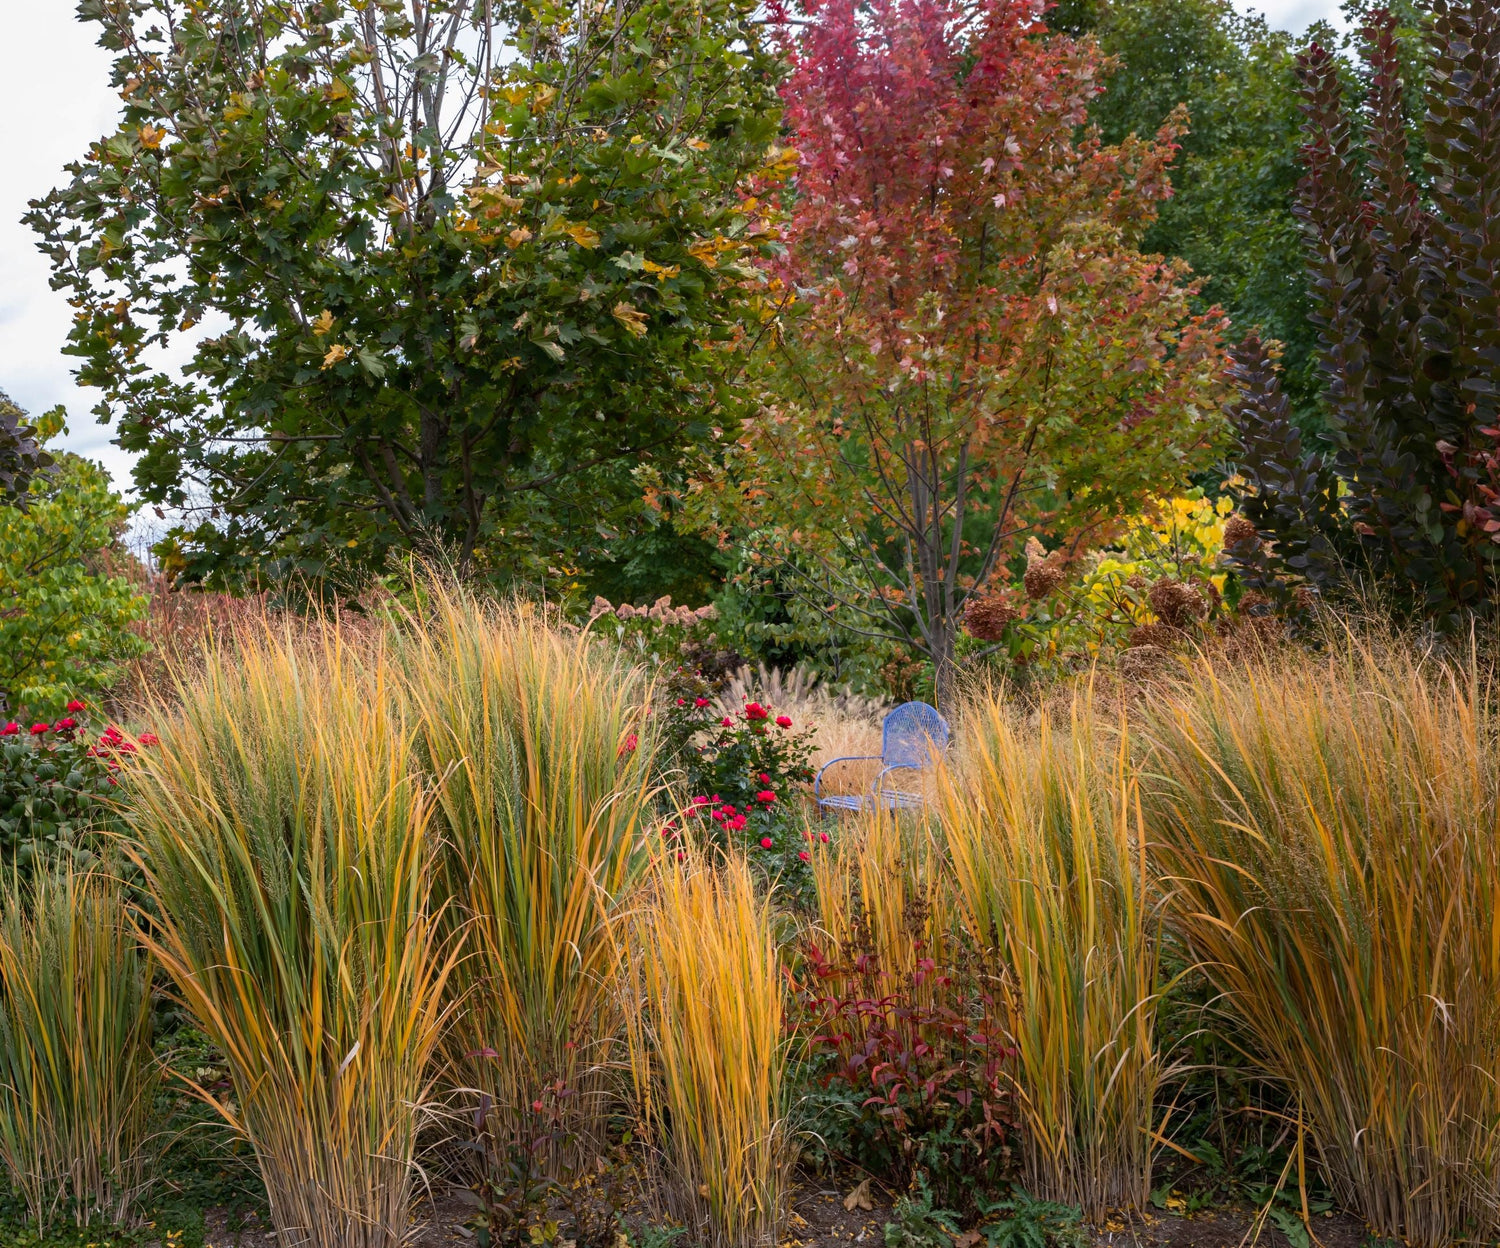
[120,620,456,1248]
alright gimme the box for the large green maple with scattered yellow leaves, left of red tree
[29,0,777,584]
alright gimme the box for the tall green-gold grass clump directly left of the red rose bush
[401,582,654,1143]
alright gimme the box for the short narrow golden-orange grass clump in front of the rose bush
[630,848,792,1248]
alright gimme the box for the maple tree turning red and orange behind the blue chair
[681,0,1223,701]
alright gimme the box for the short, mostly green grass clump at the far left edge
[0,863,161,1236]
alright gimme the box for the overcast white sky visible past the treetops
[0,0,1338,489]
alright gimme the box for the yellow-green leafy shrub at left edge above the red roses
[0,408,146,716]
